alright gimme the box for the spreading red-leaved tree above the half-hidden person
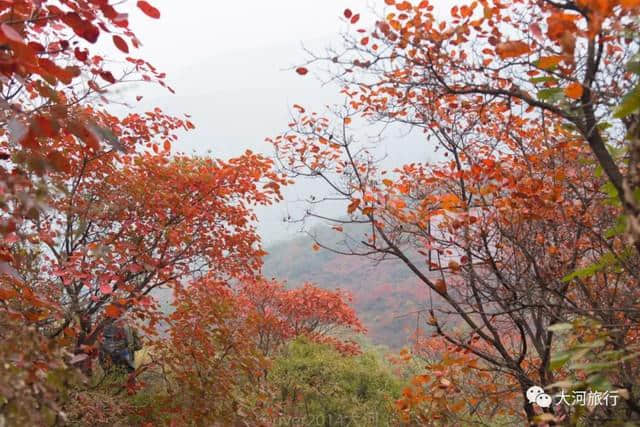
[8,130,279,364]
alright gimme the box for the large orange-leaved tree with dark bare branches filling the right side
[272,0,638,419]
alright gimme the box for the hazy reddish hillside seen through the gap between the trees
[264,228,436,348]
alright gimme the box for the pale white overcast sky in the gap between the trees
[116,0,440,244]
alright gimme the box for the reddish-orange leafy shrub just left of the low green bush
[152,274,273,425]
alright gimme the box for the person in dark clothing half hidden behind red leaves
[100,319,142,373]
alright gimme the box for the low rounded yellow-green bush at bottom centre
[268,338,401,426]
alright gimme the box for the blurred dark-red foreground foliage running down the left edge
[0,0,190,425]
